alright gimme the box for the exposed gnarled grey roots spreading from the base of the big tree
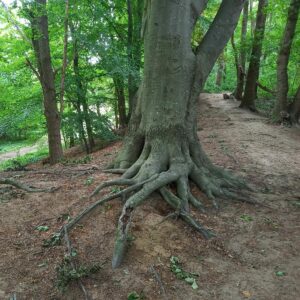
[51,138,256,268]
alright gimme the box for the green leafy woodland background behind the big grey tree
[0,0,300,160]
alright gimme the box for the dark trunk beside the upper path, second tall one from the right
[240,0,268,111]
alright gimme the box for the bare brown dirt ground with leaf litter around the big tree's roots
[0,94,300,300]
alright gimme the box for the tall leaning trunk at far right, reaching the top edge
[273,0,300,122]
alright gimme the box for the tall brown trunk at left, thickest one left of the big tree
[32,0,63,164]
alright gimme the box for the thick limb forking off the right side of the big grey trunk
[195,0,245,88]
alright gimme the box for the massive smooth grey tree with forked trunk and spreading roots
[106,0,244,267]
